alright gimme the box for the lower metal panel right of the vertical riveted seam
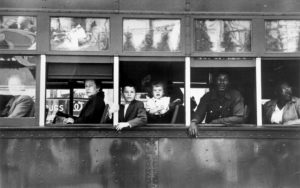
[158,138,300,188]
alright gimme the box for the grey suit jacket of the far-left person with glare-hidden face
[7,95,34,118]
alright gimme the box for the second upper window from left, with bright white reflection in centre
[50,17,110,51]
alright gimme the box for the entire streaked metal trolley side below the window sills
[0,127,300,188]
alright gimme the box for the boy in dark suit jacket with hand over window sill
[109,84,147,130]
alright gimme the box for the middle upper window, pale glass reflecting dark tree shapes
[123,19,180,52]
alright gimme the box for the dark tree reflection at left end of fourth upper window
[196,21,213,51]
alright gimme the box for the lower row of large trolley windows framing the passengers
[0,55,300,126]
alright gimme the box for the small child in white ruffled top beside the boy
[146,82,181,123]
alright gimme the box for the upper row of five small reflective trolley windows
[0,15,300,53]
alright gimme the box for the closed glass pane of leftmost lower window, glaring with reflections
[0,56,38,118]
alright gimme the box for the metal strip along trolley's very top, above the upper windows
[0,0,300,13]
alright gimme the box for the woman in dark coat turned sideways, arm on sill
[64,80,105,124]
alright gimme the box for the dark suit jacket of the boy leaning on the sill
[119,100,147,127]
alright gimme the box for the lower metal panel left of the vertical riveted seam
[0,138,155,188]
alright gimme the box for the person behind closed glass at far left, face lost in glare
[1,75,34,118]
